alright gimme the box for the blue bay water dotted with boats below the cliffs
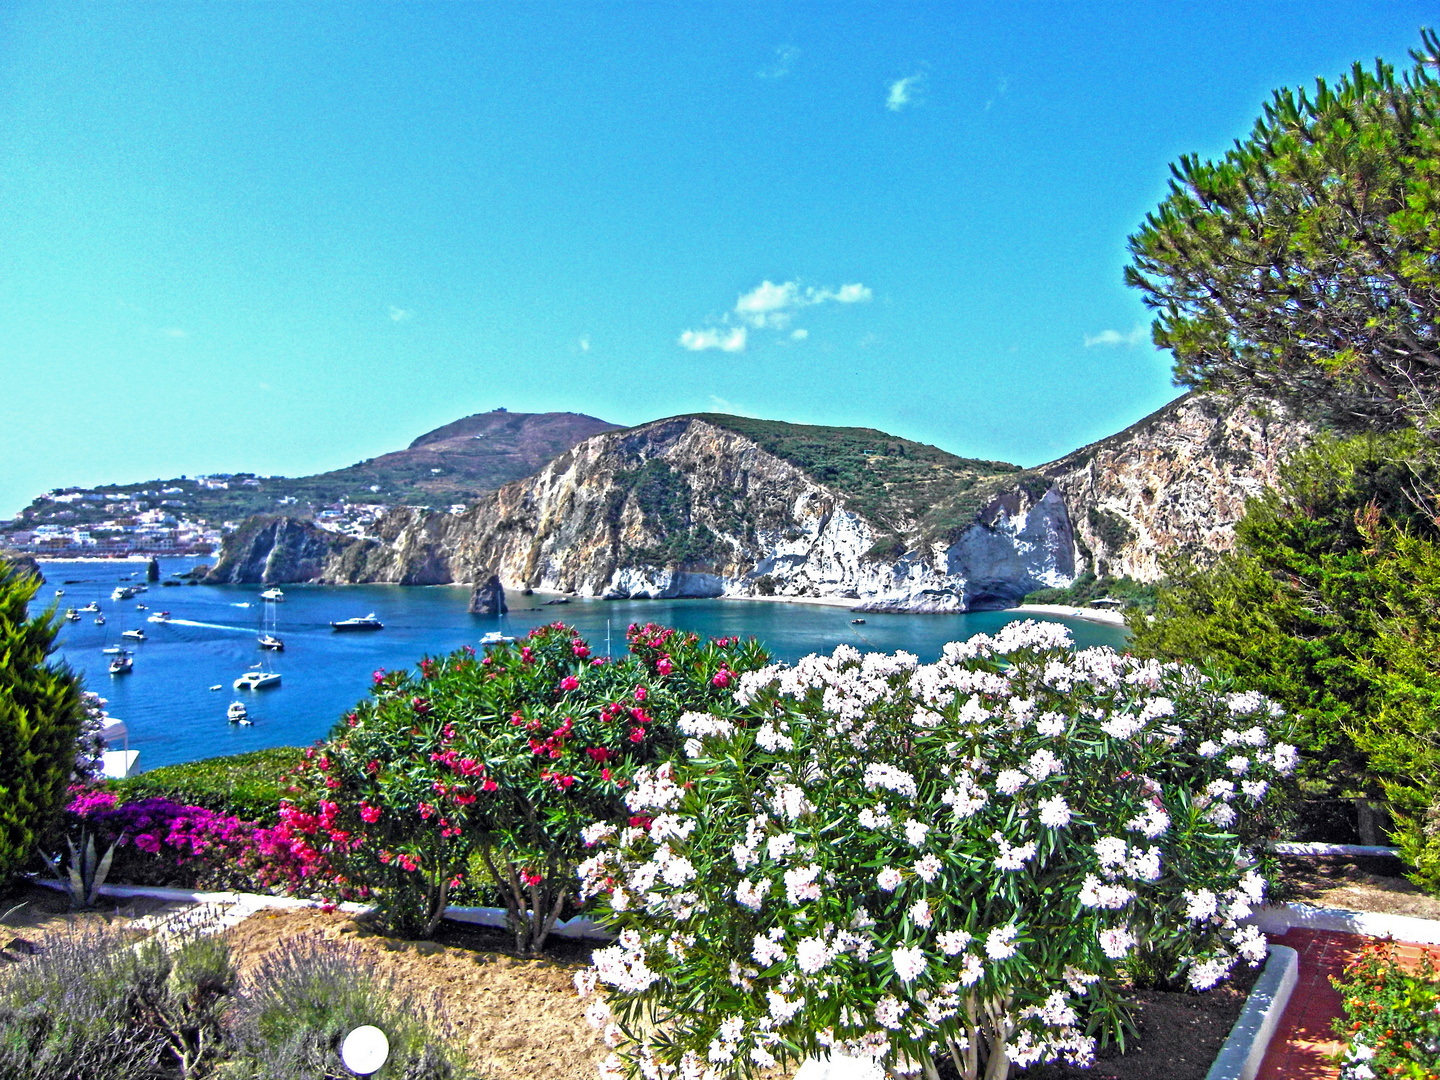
[37,559,1125,769]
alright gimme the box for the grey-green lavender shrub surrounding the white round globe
[220,935,474,1080]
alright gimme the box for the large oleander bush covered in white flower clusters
[577,622,1296,1080]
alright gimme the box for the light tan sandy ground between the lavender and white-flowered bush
[228,909,609,1080]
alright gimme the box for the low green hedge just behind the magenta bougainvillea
[107,746,305,825]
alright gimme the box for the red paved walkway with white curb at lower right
[1256,927,1426,1080]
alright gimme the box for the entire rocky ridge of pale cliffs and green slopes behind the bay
[212,395,1306,611]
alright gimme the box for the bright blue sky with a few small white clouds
[0,0,1434,514]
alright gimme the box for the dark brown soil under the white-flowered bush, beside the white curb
[1018,965,1263,1080]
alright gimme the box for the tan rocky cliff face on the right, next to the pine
[1037,395,1313,582]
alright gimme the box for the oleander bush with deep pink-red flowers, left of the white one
[281,624,766,953]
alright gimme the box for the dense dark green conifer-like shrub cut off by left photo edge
[0,563,85,881]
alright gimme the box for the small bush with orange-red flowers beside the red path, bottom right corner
[1331,942,1440,1080]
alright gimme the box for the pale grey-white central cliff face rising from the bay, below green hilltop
[295,418,1074,611]
